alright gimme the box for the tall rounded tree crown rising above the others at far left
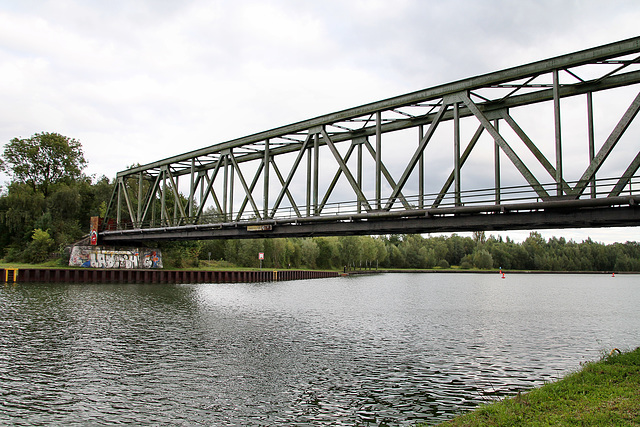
[0,132,87,197]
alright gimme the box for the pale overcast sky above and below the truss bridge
[0,0,640,242]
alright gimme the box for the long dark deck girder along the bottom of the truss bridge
[102,200,640,244]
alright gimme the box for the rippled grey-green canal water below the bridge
[0,273,640,426]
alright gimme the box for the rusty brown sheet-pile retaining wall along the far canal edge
[0,268,339,283]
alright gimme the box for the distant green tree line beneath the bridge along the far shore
[191,232,640,271]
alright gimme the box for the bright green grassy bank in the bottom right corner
[432,347,640,427]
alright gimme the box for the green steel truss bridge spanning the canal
[100,37,640,243]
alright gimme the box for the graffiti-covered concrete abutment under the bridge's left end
[69,246,162,268]
